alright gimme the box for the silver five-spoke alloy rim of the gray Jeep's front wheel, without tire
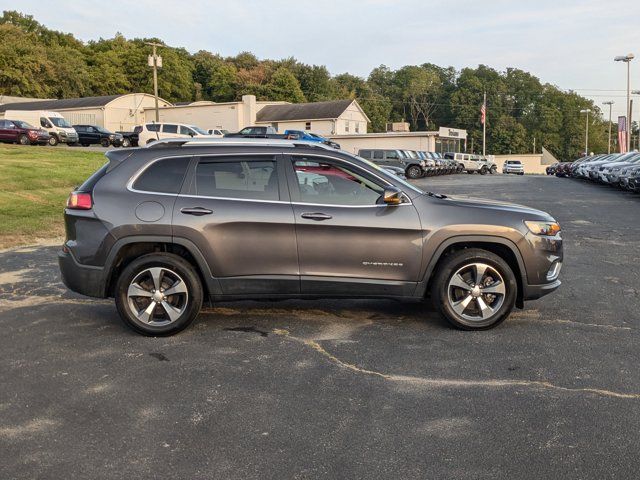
[447,262,507,324]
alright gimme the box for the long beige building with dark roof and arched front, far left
[0,93,171,131]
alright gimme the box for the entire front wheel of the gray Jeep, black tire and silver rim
[432,248,518,330]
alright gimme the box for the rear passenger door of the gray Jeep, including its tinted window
[173,154,300,295]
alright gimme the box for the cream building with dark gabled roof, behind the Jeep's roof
[255,100,369,137]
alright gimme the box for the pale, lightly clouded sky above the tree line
[7,0,640,119]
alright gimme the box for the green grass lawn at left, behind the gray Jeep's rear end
[0,144,106,248]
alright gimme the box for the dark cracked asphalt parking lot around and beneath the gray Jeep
[0,175,640,479]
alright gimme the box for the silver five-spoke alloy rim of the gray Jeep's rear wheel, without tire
[127,267,189,327]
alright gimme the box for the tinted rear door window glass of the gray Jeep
[196,159,280,200]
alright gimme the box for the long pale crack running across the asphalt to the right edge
[273,329,640,399]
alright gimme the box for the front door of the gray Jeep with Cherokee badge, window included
[287,155,422,296]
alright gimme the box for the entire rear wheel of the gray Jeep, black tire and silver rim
[115,253,203,336]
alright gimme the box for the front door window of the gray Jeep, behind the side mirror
[293,157,384,206]
